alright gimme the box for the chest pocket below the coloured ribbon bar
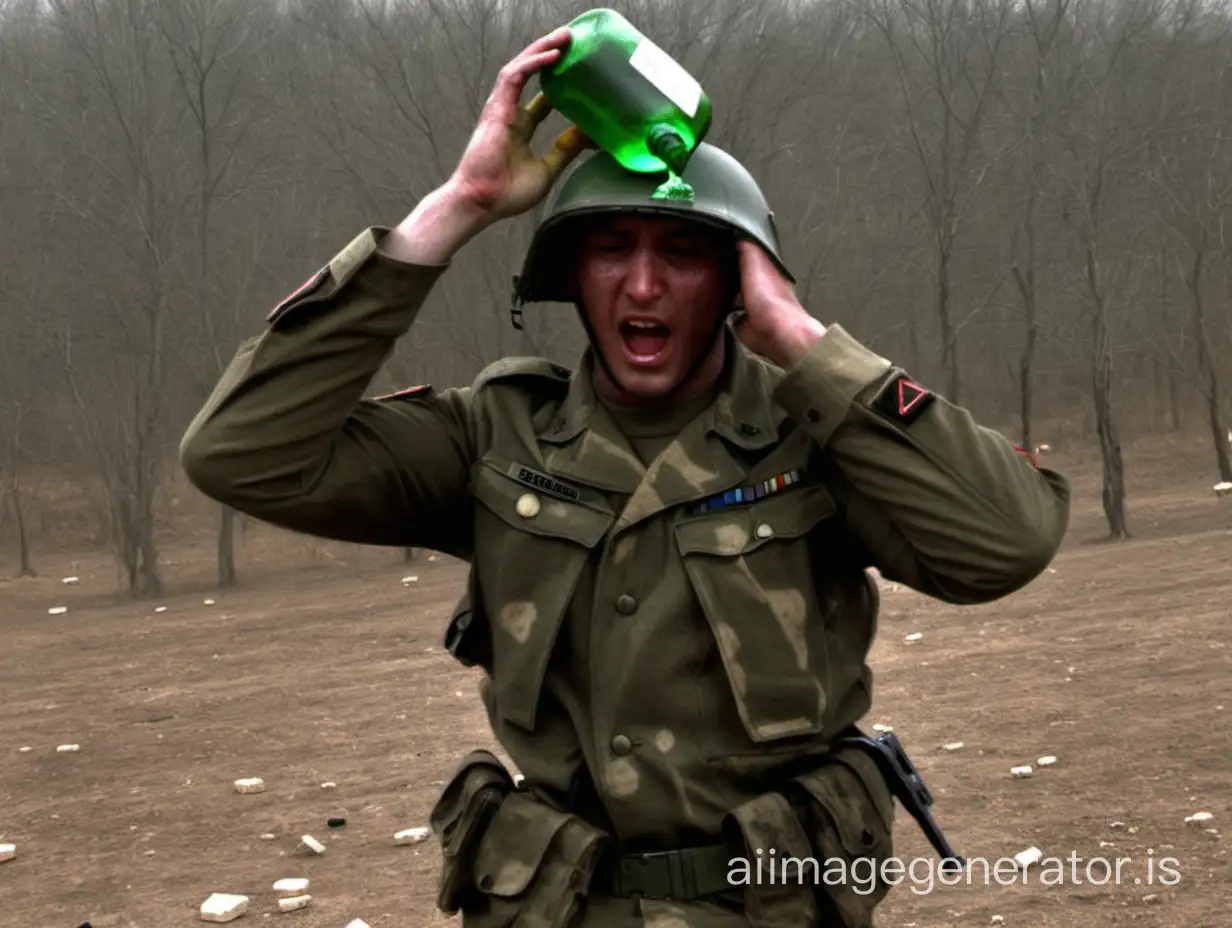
[675,486,837,743]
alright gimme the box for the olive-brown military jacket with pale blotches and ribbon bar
[181,228,1068,926]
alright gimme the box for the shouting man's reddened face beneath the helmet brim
[575,216,731,403]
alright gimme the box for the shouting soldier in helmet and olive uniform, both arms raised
[181,25,1068,928]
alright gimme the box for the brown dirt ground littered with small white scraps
[0,433,1232,928]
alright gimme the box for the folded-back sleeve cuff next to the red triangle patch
[774,325,893,446]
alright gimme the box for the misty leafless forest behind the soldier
[0,0,1232,595]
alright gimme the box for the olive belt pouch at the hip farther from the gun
[430,751,606,928]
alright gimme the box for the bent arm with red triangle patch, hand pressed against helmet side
[738,244,1069,604]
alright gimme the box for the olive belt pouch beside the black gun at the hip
[723,747,898,928]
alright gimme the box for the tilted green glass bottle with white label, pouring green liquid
[540,9,712,200]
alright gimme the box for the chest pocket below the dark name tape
[473,454,615,731]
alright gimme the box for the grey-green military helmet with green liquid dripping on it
[514,142,795,304]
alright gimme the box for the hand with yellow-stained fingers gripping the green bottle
[448,26,595,222]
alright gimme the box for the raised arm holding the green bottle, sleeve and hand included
[180,30,589,555]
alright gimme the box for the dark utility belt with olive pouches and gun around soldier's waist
[431,732,963,928]
